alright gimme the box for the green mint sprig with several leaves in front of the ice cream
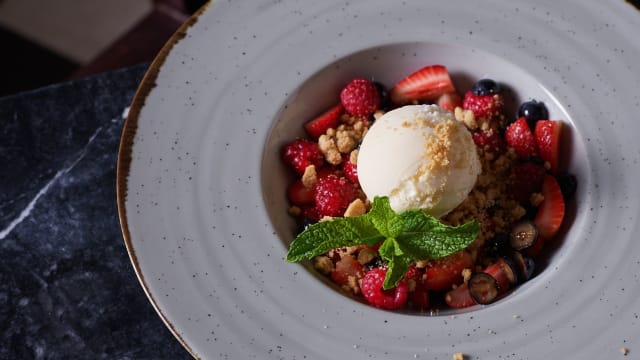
[287,197,480,290]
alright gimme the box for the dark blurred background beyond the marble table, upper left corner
[0,0,207,96]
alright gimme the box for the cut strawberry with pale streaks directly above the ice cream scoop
[389,65,456,105]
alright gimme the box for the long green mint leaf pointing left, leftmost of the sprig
[287,215,384,262]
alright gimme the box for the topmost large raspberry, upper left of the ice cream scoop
[340,78,380,116]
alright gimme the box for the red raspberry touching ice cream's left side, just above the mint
[315,174,357,216]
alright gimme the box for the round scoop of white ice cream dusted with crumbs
[358,105,481,217]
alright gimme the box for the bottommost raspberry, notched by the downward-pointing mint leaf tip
[360,268,409,310]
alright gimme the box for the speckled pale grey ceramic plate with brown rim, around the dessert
[118,0,640,359]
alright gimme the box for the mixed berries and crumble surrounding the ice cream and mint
[282,65,577,311]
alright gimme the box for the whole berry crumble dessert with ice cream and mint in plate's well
[263,44,577,313]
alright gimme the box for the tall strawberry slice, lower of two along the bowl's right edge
[533,175,565,240]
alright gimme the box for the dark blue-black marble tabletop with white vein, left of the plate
[0,65,190,359]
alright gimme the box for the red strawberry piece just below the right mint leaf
[425,250,473,291]
